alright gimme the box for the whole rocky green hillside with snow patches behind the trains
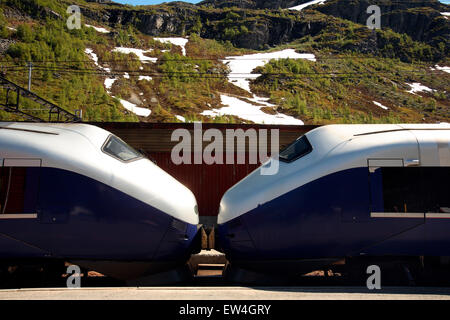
[0,0,450,124]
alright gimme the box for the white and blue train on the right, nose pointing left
[218,124,450,274]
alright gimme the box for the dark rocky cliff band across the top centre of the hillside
[82,5,326,49]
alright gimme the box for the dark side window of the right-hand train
[369,162,450,213]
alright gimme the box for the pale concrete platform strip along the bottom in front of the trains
[0,287,450,300]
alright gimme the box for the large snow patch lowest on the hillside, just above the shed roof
[201,94,304,125]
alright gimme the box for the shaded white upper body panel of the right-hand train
[218,124,450,224]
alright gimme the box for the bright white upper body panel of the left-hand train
[0,122,198,224]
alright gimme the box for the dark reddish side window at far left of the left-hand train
[0,159,41,219]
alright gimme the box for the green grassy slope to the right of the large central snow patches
[252,55,450,124]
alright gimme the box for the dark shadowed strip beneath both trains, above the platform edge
[4,262,450,296]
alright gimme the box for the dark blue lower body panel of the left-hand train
[0,168,197,270]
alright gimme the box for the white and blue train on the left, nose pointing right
[0,123,199,280]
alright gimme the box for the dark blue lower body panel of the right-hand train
[218,167,450,270]
